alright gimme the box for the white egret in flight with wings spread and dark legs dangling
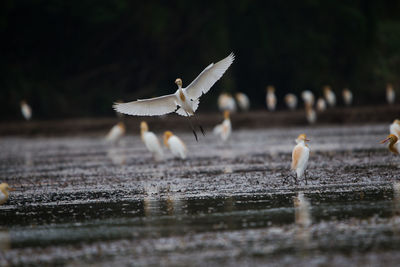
[114,53,235,140]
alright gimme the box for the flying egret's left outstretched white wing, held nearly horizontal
[113,94,178,116]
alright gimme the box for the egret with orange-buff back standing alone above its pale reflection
[292,134,310,183]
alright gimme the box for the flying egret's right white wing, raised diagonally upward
[185,53,235,100]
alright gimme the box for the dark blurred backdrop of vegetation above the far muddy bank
[0,0,400,119]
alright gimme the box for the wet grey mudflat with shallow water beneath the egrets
[0,124,400,266]
